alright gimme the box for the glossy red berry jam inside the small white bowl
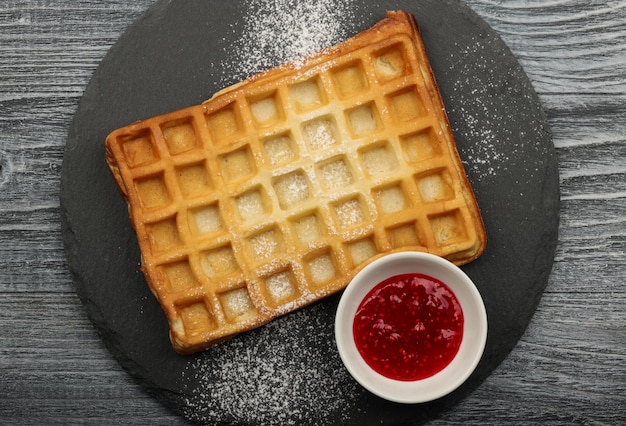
[353,274,463,381]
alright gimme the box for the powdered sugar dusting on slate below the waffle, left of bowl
[178,305,362,425]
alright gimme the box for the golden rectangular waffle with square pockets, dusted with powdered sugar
[106,11,485,353]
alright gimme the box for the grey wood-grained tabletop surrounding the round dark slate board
[0,0,626,424]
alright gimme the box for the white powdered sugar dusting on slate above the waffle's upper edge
[229,0,354,80]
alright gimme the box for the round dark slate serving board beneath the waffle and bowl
[61,0,559,424]
